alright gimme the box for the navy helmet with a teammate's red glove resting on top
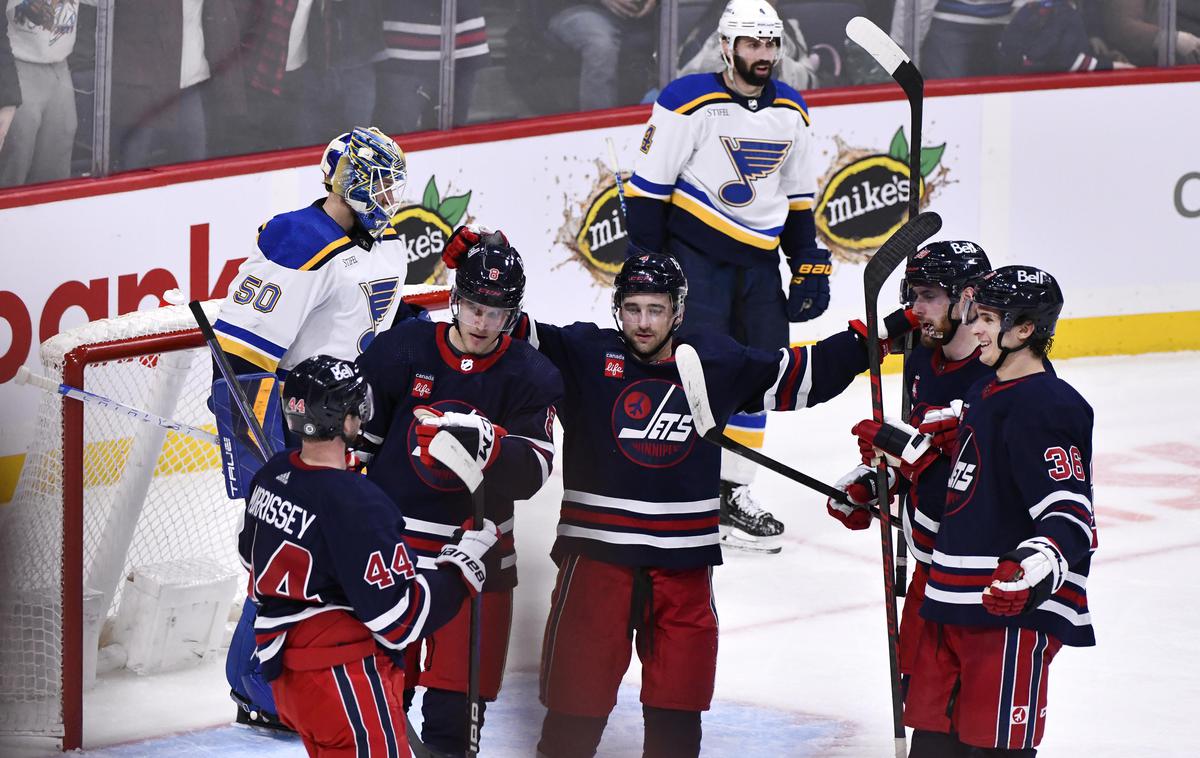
[450,231,526,332]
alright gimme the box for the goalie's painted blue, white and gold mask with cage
[326,126,408,239]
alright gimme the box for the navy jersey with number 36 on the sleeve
[920,367,1097,646]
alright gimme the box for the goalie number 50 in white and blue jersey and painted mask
[220,127,410,726]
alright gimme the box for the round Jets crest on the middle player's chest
[612,379,696,469]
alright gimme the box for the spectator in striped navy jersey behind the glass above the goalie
[376,0,490,133]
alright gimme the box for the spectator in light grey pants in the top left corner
[0,0,79,187]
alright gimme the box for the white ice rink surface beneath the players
[0,353,1200,758]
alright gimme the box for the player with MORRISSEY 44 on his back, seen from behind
[238,355,499,756]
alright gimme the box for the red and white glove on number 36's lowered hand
[983,537,1067,615]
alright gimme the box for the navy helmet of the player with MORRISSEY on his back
[283,355,374,441]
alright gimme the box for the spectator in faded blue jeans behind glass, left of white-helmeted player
[544,0,657,110]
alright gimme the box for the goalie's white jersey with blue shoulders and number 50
[219,201,408,372]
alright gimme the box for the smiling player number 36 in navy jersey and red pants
[854,266,1096,758]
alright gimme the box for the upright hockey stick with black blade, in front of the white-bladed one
[863,212,942,758]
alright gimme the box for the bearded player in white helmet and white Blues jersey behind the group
[628,0,832,549]
